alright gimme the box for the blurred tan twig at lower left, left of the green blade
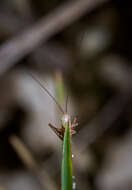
[9,135,57,190]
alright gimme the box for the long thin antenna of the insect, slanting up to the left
[30,73,65,114]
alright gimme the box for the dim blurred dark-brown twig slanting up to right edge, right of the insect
[75,93,131,148]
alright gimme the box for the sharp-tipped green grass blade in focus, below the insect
[61,122,72,190]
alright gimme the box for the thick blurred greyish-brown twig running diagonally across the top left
[0,0,107,74]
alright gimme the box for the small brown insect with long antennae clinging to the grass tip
[30,73,78,141]
